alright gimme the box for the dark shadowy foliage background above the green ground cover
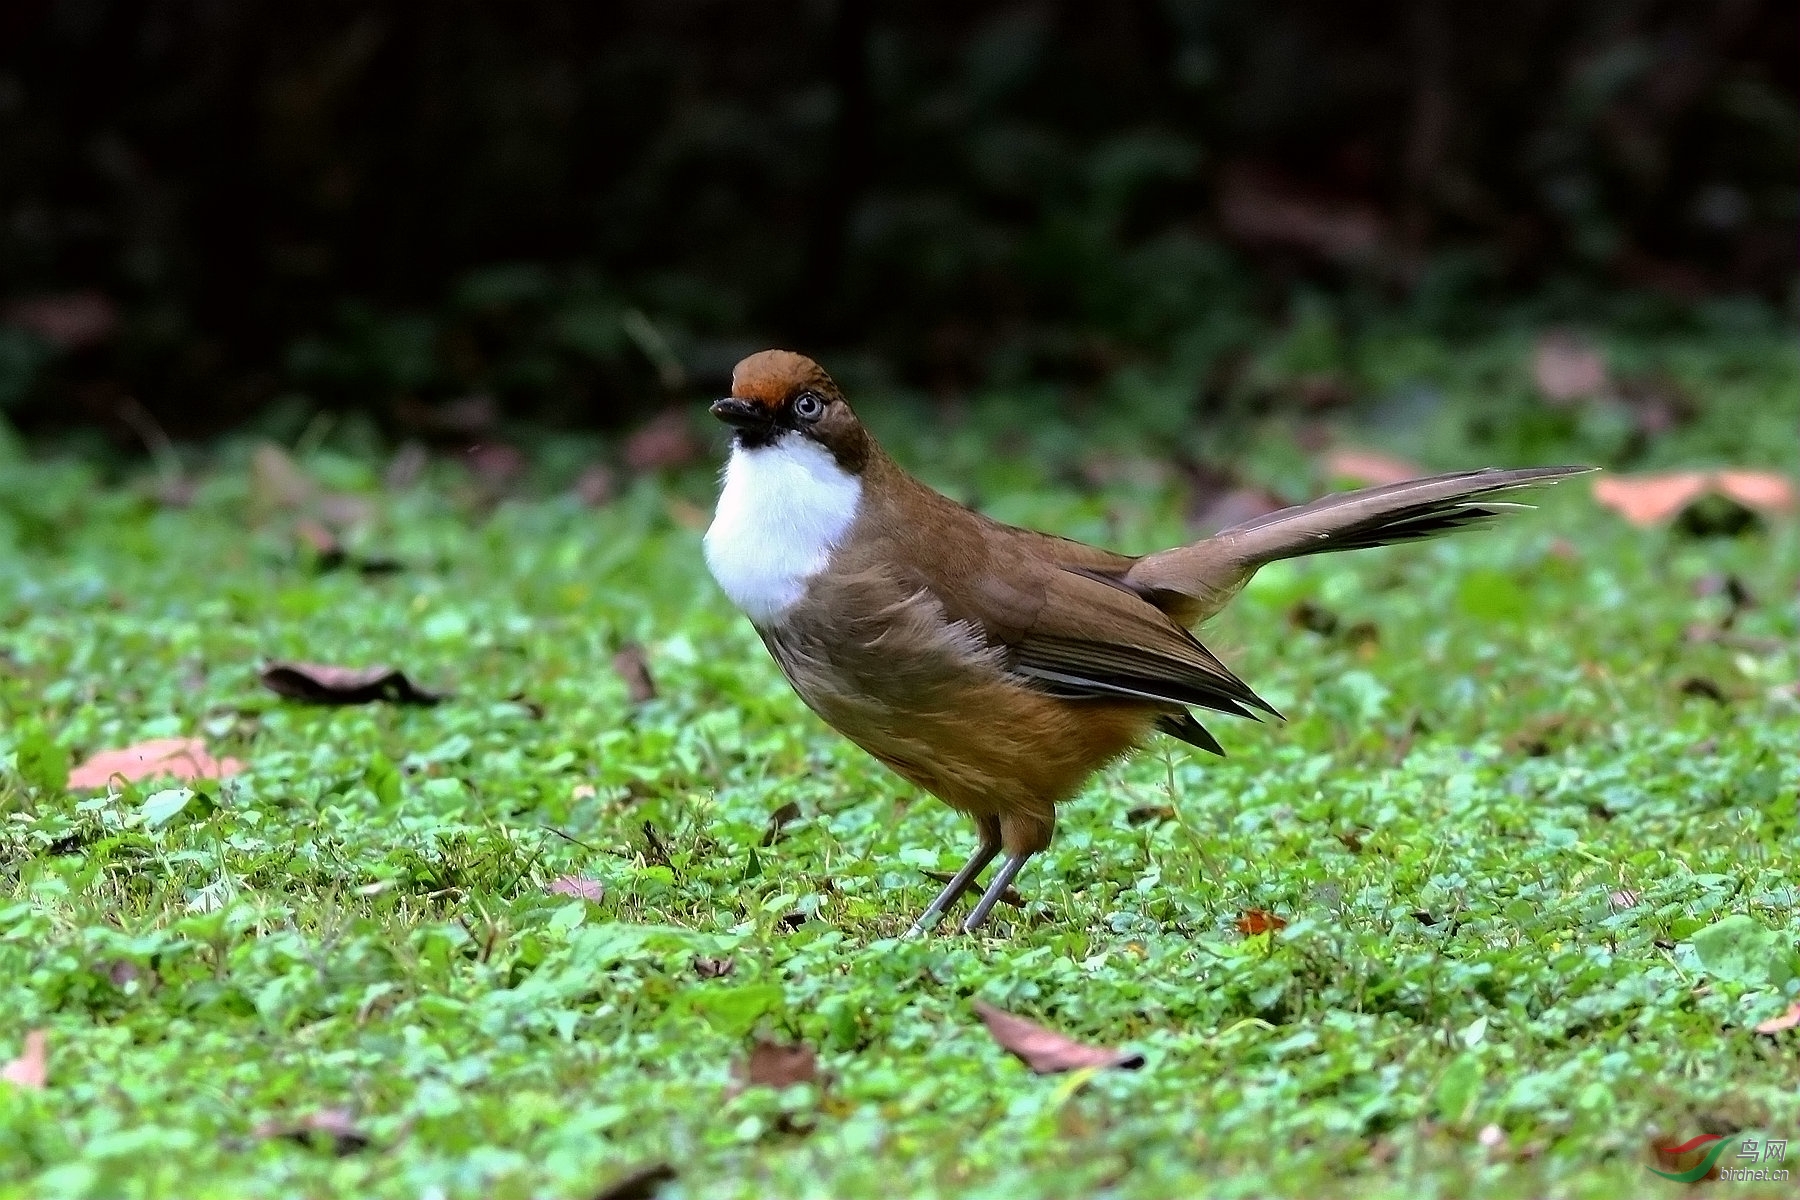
[0,0,1800,434]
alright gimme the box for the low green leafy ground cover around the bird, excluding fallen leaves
[0,329,1800,1200]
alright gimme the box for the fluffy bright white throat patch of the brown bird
[706,434,862,626]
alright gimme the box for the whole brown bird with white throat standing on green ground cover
[706,351,1588,934]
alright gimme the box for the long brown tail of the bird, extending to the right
[1125,466,1593,624]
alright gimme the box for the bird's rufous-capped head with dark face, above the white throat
[713,351,869,471]
